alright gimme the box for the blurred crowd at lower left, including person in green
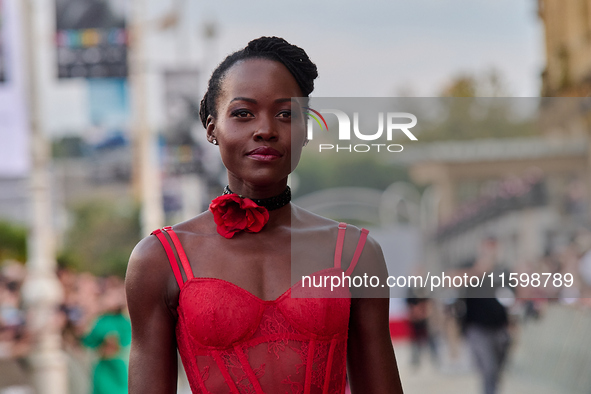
[0,262,131,394]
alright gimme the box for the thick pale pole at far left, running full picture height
[17,0,68,394]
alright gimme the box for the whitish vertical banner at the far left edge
[0,0,30,178]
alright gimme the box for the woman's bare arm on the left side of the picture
[125,237,178,394]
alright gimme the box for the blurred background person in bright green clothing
[82,277,131,394]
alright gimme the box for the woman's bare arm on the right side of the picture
[347,238,403,394]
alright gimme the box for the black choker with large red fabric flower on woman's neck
[209,186,291,238]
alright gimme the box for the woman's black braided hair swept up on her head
[199,37,318,128]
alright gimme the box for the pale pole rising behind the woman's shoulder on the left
[129,0,164,235]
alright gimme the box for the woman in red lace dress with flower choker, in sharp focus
[126,37,402,394]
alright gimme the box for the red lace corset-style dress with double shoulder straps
[153,223,368,394]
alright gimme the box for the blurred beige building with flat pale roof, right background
[410,136,587,269]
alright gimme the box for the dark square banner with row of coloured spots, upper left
[55,0,128,78]
